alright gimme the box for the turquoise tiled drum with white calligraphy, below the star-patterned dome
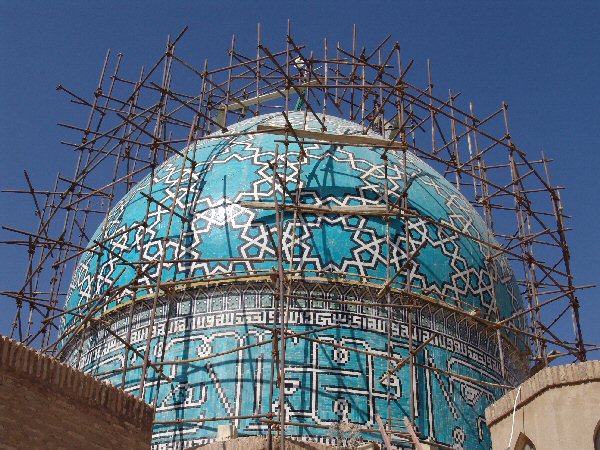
[61,283,523,449]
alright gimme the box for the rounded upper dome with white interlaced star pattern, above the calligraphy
[67,112,521,319]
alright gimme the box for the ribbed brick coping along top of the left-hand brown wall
[0,335,154,427]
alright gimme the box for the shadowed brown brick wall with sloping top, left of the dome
[0,336,154,450]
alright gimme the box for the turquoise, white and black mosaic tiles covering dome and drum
[63,112,524,448]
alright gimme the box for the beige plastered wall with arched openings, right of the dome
[486,361,600,450]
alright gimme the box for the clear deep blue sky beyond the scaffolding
[0,1,600,358]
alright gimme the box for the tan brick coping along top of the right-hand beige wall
[485,360,600,427]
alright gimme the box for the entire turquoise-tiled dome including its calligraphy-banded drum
[61,112,526,449]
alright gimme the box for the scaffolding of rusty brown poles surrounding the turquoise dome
[1,23,594,448]
